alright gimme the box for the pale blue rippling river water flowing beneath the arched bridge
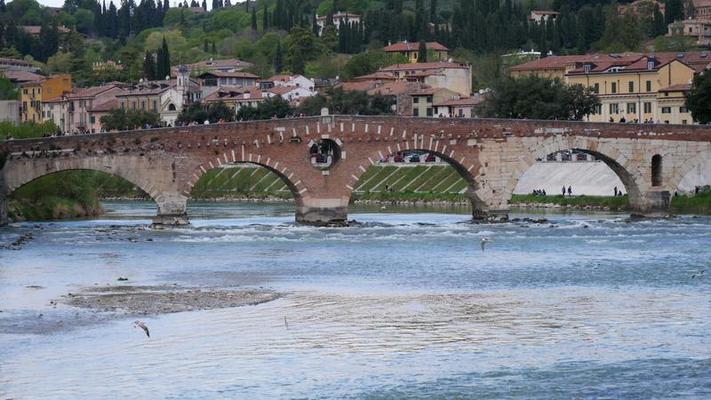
[0,203,711,399]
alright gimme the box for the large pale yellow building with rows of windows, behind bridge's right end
[565,56,696,123]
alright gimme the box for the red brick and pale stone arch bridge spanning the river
[0,115,711,225]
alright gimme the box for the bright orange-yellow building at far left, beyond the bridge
[20,74,72,122]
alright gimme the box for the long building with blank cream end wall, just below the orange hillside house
[379,62,472,97]
